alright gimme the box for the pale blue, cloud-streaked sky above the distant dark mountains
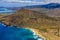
[0,0,60,7]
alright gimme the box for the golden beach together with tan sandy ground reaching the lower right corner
[27,28,60,40]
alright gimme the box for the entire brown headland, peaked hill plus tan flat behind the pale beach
[0,9,60,40]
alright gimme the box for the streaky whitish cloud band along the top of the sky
[1,0,60,4]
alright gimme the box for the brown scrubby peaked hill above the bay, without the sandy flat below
[1,9,60,28]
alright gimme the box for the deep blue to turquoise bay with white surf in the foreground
[0,23,43,40]
